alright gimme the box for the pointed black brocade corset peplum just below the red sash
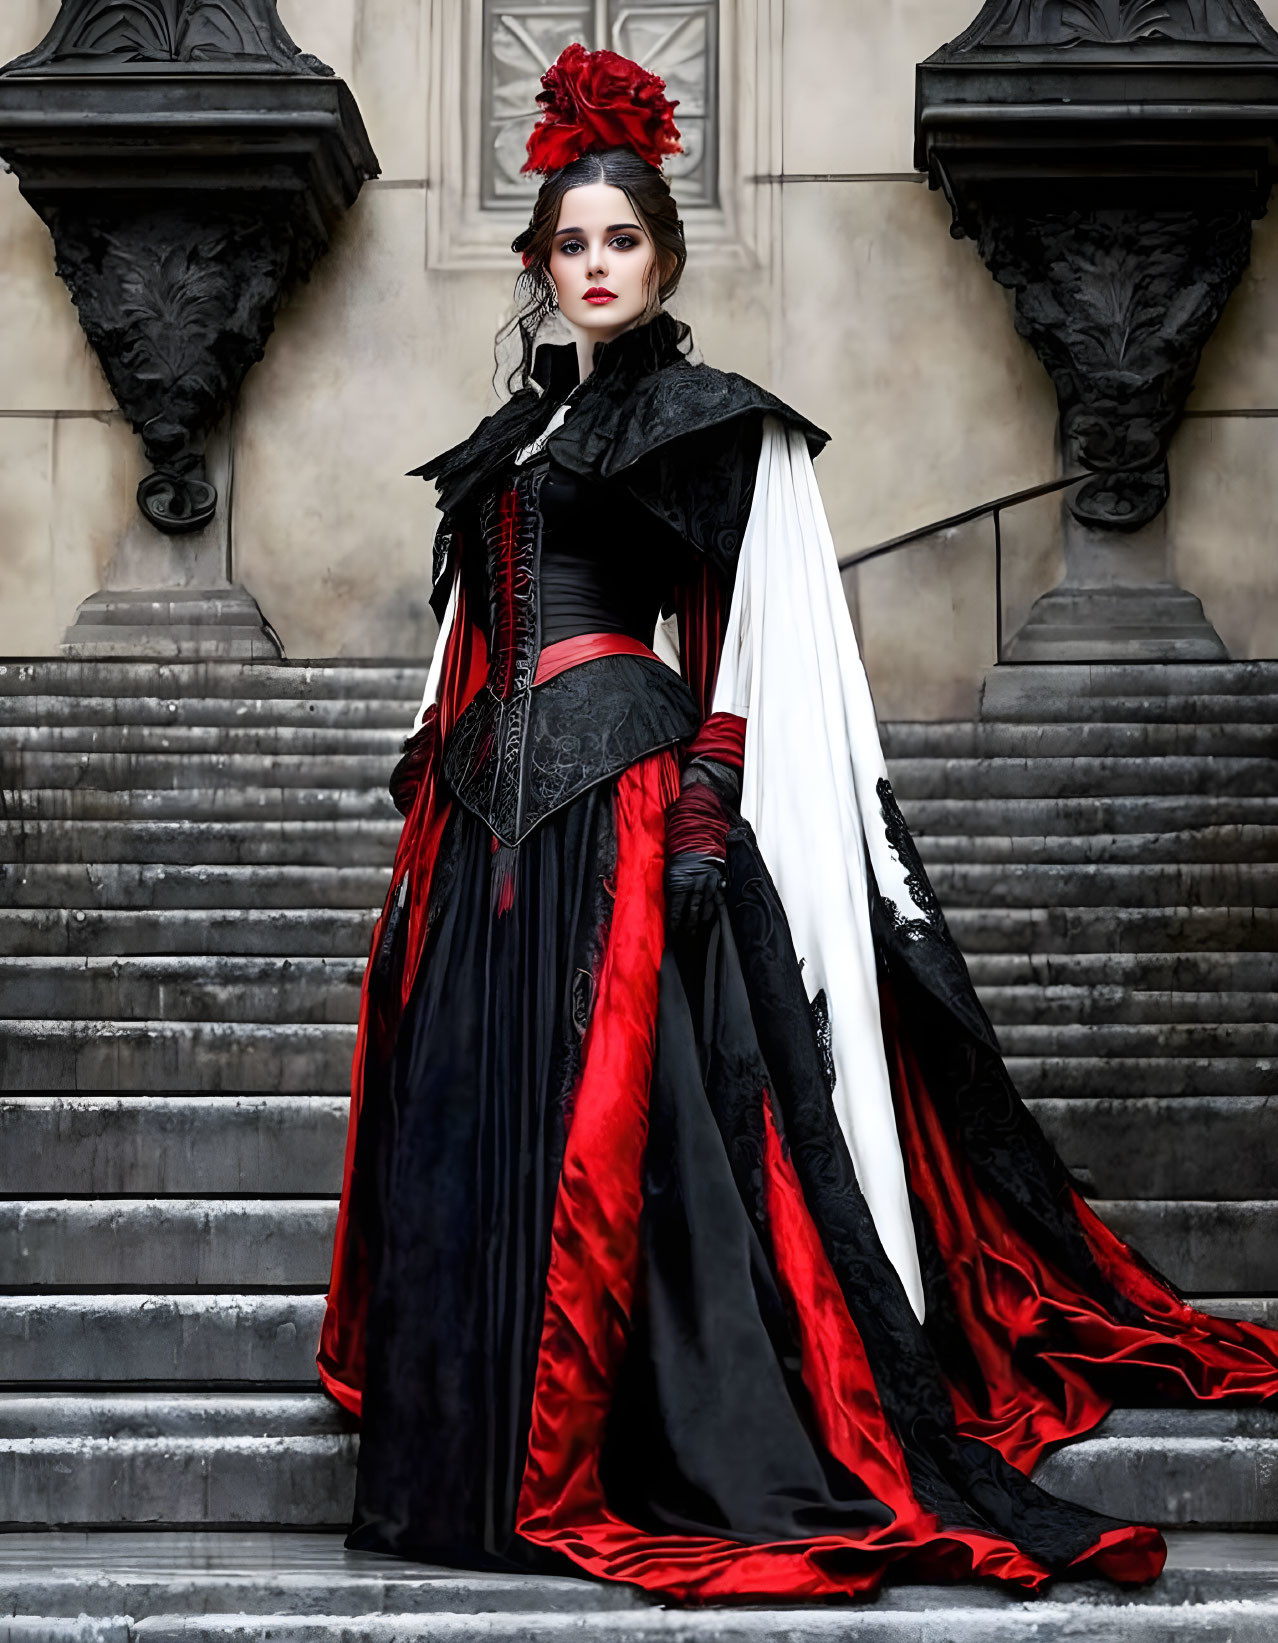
[444,656,698,845]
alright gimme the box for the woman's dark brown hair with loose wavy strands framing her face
[498,148,688,391]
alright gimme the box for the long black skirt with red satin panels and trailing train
[336,756,1278,1600]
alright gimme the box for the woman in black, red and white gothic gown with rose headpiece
[320,46,1278,1600]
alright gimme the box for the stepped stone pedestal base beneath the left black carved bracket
[61,585,284,662]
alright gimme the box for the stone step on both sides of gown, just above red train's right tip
[0,1198,1278,1295]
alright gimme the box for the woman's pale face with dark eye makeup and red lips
[550,182,657,342]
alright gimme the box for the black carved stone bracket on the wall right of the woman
[917,0,1278,656]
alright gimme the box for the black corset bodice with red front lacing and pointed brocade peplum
[444,455,696,845]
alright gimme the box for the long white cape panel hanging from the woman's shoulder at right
[715,417,923,1319]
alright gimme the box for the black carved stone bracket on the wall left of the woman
[0,0,378,654]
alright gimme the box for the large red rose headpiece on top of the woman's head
[521,41,683,171]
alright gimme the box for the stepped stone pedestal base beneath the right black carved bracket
[1004,582,1229,662]
